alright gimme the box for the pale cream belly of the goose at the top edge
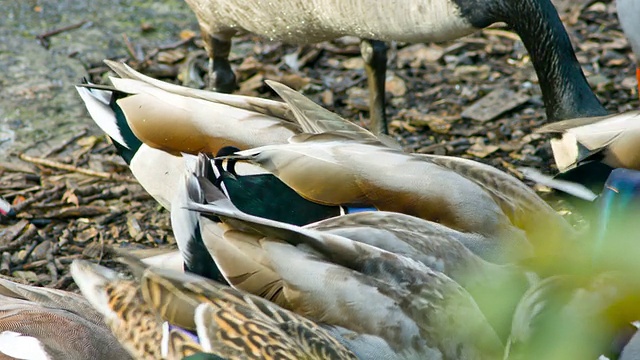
[186,0,478,44]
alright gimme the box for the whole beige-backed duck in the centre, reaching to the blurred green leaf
[226,133,573,262]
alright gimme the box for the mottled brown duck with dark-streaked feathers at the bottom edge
[71,260,376,359]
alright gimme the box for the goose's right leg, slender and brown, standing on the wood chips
[360,39,389,134]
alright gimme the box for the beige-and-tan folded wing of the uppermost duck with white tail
[111,78,299,154]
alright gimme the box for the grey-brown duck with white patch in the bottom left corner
[0,278,131,360]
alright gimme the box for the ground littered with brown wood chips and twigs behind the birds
[0,1,638,288]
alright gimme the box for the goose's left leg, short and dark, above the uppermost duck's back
[202,31,236,93]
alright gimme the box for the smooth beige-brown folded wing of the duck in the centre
[239,134,524,252]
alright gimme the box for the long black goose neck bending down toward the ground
[457,0,607,121]
